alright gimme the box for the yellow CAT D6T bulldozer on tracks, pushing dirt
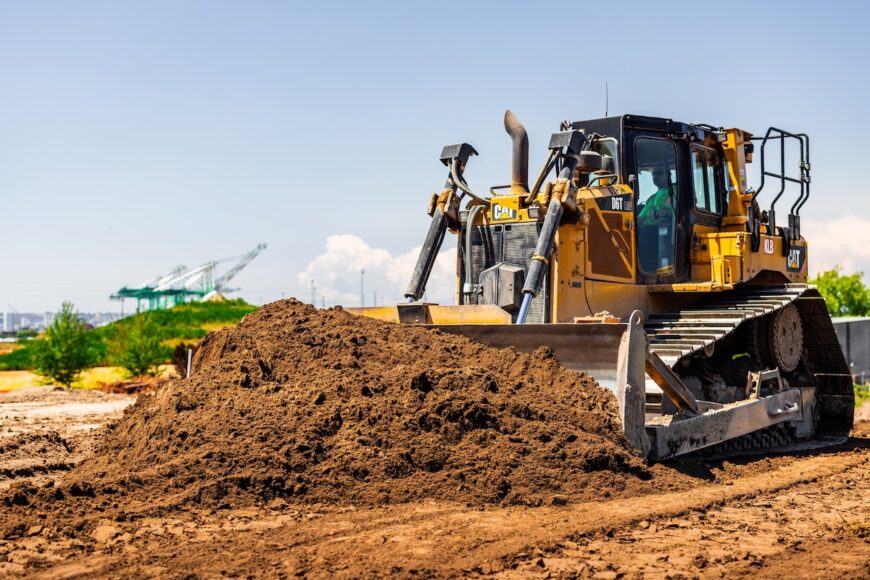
[352,111,854,460]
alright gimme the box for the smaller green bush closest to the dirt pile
[109,312,166,377]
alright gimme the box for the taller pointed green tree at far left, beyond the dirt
[29,302,100,388]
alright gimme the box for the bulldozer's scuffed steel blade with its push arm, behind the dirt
[429,312,812,461]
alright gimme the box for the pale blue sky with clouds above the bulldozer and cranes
[0,0,870,311]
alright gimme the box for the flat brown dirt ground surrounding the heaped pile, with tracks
[0,388,870,578]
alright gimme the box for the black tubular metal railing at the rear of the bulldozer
[750,127,810,249]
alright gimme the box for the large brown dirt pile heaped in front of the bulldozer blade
[56,300,645,507]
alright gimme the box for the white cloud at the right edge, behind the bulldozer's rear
[801,215,870,276]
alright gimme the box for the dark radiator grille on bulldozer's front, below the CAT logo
[458,222,549,323]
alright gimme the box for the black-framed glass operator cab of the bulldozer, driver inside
[572,115,729,284]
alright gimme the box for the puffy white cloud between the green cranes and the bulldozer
[296,234,456,306]
